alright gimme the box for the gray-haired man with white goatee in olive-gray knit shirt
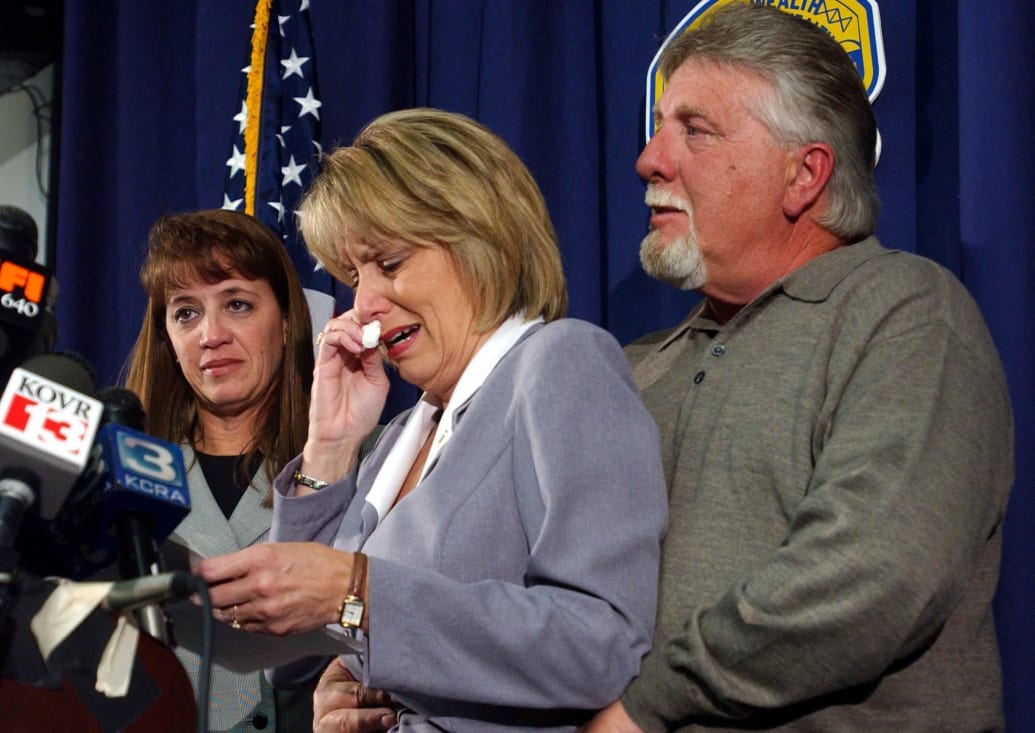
[588,4,1013,732]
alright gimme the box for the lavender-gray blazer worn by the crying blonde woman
[271,320,667,732]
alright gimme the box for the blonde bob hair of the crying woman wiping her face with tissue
[299,109,568,331]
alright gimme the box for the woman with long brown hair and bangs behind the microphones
[125,209,313,731]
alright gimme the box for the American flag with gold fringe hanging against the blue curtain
[223,0,336,331]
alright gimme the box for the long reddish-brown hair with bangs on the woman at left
[125,209,313,492]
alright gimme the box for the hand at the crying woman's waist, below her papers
[313,656,395,733]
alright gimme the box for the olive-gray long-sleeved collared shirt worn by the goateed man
[622,238,1013,731]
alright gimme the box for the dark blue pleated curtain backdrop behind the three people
[50,0,1035,730]
